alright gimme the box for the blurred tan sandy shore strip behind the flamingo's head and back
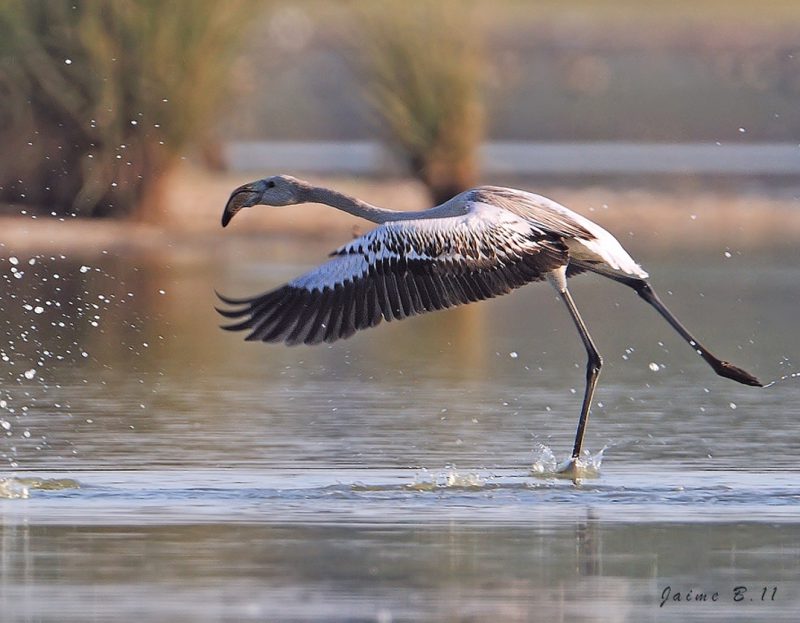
[0,165,800,256]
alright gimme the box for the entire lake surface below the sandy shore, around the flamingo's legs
[0,235,800,622]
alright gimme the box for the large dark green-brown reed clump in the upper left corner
[0,0,262,218]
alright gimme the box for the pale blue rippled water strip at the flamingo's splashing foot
[0,467,800,525]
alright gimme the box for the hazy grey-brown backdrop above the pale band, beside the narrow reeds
[221,0,800,143]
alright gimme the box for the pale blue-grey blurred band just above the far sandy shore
[227,140,800,180]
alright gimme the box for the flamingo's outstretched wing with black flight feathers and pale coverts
[219,203,568,344]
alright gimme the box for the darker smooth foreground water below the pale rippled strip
[0,522,800,621]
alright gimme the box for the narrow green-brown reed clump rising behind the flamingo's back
[354,0,484,203]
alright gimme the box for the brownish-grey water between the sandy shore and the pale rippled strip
[0,248,800,468]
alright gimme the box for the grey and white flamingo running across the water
[218,175,763,468]
